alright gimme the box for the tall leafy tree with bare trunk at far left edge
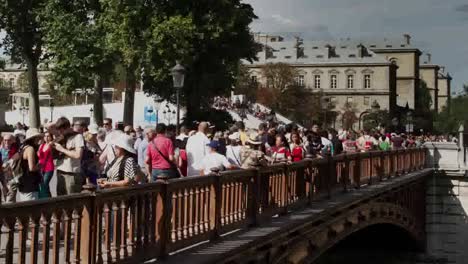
[0,0,46,128]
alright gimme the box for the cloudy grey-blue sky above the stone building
[244,0,468,95]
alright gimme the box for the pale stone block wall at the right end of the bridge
[425,143,468,264]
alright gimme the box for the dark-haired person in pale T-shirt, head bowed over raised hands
[54,117,85,196]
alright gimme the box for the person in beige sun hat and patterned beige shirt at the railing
[240,133,267,169]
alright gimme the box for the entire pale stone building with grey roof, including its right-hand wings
[246,34,451,128]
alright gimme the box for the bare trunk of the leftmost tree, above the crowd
[26,58,41,128]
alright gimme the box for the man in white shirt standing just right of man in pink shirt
[186,122,210,176]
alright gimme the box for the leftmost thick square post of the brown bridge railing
[79,184,96,264]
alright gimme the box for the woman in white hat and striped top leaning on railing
[98,133,140,189]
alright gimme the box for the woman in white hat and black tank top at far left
[18,128,42,202]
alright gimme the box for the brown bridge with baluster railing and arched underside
[0,149,433,263]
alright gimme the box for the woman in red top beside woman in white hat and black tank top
[37,133,55,198]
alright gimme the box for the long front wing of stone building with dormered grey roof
[244,40,398,128]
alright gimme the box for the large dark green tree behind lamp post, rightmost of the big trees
[144,0,259,124]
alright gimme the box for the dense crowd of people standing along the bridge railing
[0,117,453,202]
